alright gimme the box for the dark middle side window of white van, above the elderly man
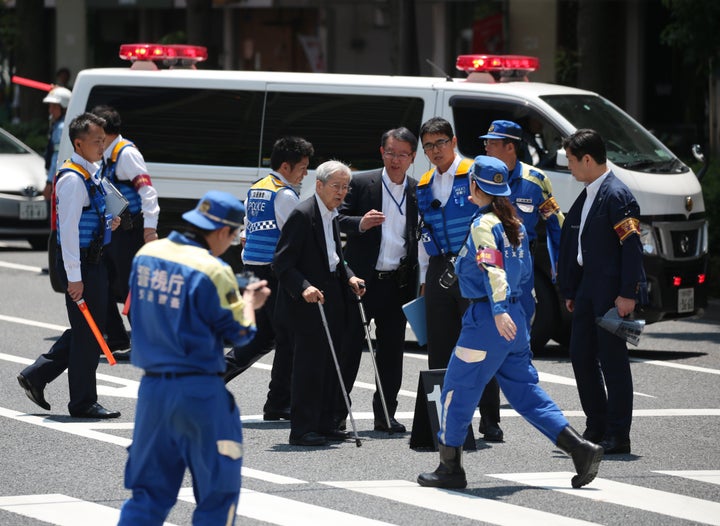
[262,92,423,170]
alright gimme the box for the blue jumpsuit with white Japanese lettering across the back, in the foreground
[119,232,255,526]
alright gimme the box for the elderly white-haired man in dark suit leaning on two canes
[273,161,364,446]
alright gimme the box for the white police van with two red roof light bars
[60,44,708,349]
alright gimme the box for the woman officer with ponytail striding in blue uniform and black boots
[417,155,603,488]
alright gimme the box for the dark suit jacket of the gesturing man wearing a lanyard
[338,169,418,297]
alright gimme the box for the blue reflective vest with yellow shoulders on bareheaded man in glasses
[417,159,477,256]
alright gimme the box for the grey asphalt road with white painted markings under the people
[0,242,720,526]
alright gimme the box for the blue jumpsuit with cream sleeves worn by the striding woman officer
[438,206,568,447]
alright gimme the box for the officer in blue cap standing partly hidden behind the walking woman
[480,120,564,446]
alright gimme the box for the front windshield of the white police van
[542,95,689,173]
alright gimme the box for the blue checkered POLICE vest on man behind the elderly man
[243,174,297,263]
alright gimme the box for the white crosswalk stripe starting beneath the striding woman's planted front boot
[322,478,595,526]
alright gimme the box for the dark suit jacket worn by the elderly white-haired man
[273,195,355,328]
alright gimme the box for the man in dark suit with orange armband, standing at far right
[558,129,646,454]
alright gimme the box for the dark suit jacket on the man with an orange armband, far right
[558,172,646,308]
